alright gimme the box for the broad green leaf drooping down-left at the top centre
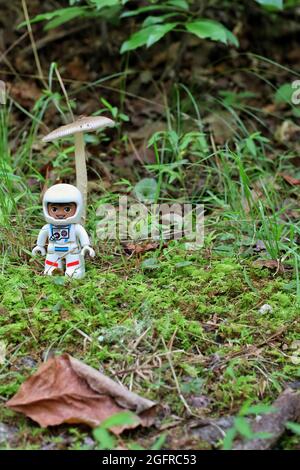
[121,23,178,54]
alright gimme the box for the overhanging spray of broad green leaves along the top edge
[27,0,238,54]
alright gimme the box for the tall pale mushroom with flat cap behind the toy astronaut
[42,116,115,221]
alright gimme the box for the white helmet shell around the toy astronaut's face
[43,184,83,225]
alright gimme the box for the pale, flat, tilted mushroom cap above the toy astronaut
[42,116,115,142]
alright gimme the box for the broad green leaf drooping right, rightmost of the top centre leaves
[185,19,239,47]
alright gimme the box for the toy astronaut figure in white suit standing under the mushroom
[32,184,95,279]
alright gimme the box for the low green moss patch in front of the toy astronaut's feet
[0,242,300,449]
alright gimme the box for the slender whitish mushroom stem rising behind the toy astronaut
[74,132,87,223]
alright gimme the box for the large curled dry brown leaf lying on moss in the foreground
[6,354,155,434]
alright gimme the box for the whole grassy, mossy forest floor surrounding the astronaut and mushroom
[0,1,300,449]
